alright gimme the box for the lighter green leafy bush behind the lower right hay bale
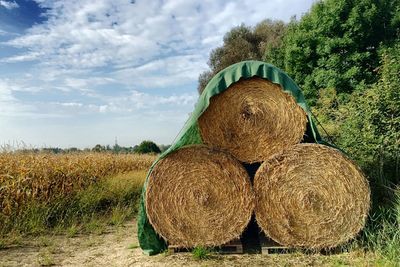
[315,44,400,203]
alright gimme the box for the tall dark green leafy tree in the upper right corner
[274,0,400,104]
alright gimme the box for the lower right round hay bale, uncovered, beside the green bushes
[254,144,370,249]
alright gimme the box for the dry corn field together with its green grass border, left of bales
[0,152,156,240]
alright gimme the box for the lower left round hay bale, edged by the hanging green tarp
[146,145,254,247]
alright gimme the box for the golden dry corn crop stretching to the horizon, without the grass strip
[0,153,155,215]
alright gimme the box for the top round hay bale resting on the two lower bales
[198,77,307,163]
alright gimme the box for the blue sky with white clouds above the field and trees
[0,0,313,148]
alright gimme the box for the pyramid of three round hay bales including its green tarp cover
[139,62,370,255]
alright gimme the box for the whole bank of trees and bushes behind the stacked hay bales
[198,0,400,203]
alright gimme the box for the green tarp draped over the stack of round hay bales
[138,61,326,255]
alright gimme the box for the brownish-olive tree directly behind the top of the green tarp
[198,19,286,93]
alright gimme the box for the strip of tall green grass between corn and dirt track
[0,170,146,237]
